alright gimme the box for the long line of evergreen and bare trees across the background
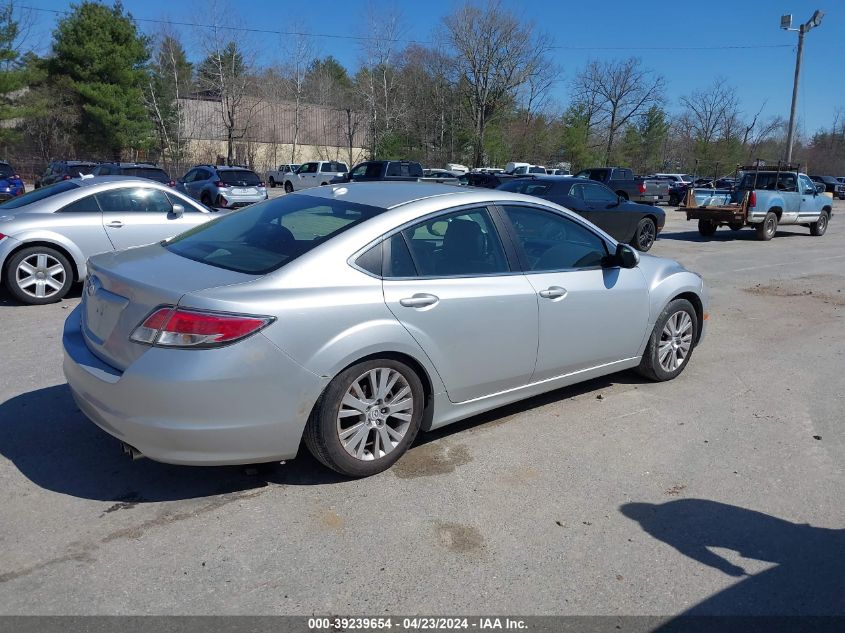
[0,0,845,175]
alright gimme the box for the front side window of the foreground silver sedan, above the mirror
[504,205,607,272]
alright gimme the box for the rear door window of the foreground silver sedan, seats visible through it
[402,209,508,277]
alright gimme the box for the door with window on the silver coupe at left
[96,187,199,250]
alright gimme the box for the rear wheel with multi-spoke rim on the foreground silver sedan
[304,358,424,477]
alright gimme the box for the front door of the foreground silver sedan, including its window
[502,205,649,382]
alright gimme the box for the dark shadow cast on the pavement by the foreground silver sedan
[0,372,645,503]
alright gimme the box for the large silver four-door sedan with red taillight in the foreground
[64,183,708,476]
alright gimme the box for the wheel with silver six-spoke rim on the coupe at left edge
[4,246,74,305]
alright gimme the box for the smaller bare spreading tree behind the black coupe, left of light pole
[574,57,665,165]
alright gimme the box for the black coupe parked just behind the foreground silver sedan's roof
[497,176,666,252]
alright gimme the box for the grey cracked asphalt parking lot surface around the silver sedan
[0,201,845,615]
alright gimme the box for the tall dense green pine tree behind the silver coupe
[49,0,151,157]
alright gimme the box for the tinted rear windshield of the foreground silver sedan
[165,194,384,275]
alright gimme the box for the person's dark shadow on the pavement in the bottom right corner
[620,499,845,616]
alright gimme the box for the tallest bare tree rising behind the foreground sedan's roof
[443,0,550,167]
